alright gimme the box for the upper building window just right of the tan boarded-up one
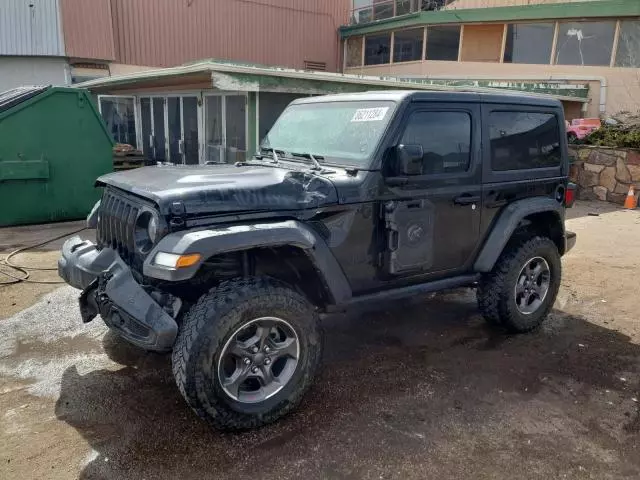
[504,23,555,65]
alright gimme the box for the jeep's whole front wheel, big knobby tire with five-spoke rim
[172,278,322,430]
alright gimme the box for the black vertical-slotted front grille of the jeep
[96,189,140,265]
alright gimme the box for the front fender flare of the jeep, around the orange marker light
[143,220,352,304]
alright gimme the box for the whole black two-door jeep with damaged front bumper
[59,92,575,429]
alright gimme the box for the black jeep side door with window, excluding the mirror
[382,103,481,279]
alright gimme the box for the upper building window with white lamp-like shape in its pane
[556,21,616,66]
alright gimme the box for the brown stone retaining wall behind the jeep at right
[569,145,640,204]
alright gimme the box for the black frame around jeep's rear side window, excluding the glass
[482,103,568,183]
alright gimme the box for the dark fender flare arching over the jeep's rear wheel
[474,198,564,273]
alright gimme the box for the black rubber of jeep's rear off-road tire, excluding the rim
[477,236,562,333]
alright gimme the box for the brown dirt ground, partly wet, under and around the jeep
[0,203,640,480]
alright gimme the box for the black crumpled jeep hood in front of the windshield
[96,165,338,216]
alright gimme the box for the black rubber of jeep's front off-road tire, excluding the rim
[172,277,322,430]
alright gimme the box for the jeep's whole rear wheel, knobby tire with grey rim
[477,237,562,333]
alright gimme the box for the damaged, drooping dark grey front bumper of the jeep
[58,236,178,352]
